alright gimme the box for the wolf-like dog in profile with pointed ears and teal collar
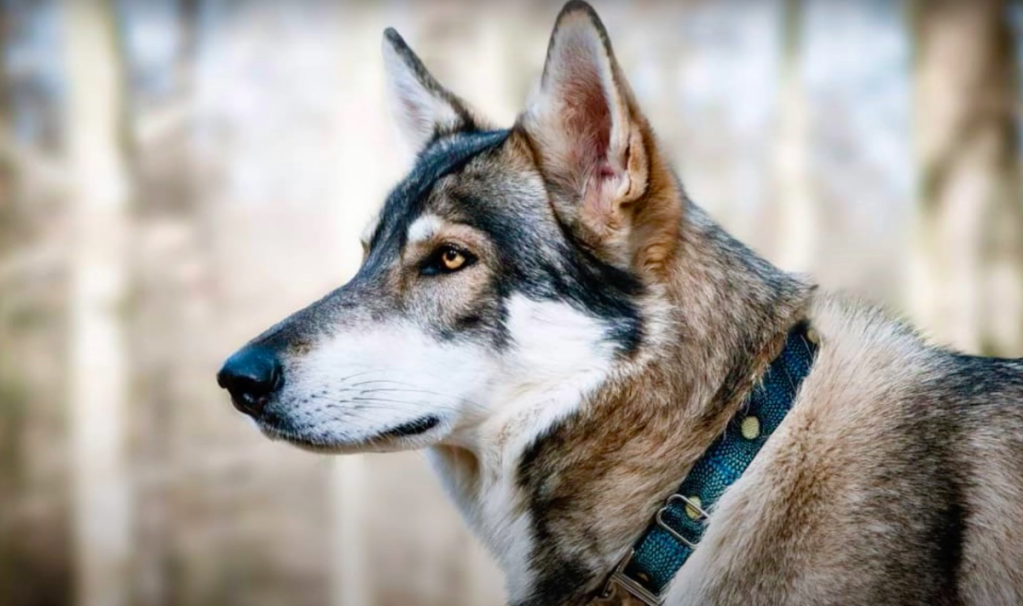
[218,1,1023,606]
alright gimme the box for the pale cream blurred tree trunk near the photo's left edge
[62,0,132,606]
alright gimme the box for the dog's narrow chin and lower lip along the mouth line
[257,415,444,455]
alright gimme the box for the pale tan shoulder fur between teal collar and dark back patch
[669,299,941,604]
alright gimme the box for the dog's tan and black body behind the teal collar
[668,296,1023,606]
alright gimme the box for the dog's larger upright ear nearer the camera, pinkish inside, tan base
[522,0,681,270]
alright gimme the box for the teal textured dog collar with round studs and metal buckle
[601,322,817,606]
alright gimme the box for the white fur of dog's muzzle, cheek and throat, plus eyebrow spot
[285,292,615,601]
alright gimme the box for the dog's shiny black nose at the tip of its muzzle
[217,347,282,417]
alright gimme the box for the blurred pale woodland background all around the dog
[0,0,1023,606]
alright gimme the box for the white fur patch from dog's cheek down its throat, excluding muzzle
[435,295,614,603]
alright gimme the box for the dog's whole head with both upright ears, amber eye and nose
[218,2,681,451]
